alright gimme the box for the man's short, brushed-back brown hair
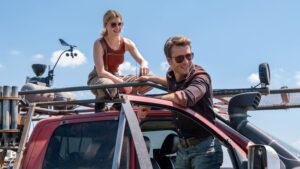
[164,35,191,58]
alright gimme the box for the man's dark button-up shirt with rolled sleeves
[167,65,215,139]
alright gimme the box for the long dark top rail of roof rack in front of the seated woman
[19,82,166,95]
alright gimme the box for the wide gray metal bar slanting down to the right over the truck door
[122,96,153,169]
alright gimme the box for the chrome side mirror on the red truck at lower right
[248,145,280,169]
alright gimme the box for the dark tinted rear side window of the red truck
[43,120,130,169]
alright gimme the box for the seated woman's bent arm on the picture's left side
[93,39,123,83]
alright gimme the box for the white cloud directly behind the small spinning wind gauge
[51,50,86,67]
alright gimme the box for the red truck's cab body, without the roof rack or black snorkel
[15,90,300,169]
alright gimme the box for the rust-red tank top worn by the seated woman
[100,38,125,73]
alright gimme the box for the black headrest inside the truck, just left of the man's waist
[160,134,179,155]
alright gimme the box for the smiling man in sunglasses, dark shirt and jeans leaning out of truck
[139,36,223,169]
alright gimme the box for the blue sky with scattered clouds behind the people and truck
[0,0,300,149]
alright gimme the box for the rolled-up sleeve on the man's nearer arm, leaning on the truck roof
[178,74,210,107]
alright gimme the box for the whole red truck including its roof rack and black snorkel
[0,62,300,169]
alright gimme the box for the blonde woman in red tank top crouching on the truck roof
[87,10,151,111]
